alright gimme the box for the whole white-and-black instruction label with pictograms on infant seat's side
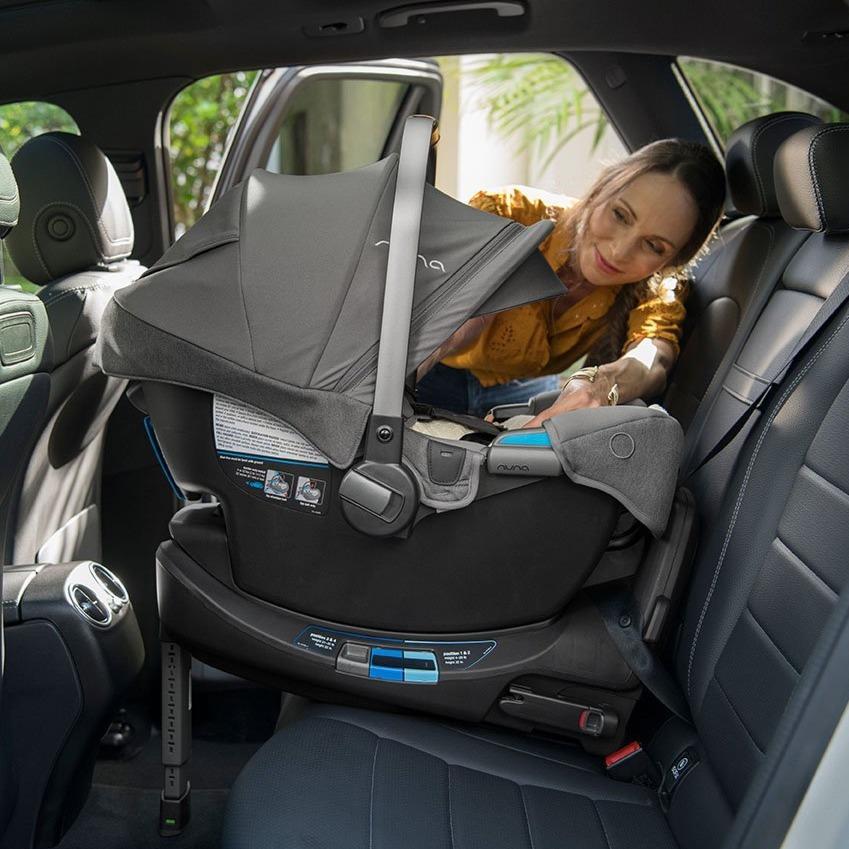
[212,395,330,515]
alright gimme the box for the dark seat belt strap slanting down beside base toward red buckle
[596,593,692,724]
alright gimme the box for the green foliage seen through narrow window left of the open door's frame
[169,71,257,235]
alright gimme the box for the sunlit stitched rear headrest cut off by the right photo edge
[775,124,849,233]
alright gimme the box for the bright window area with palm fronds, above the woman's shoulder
[437,53,627,200]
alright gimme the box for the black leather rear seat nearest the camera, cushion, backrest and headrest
[222,125,849,849]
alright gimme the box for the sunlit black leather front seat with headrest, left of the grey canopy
[2,132,144,563]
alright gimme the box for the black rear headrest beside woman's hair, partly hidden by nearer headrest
[725,112,822,218]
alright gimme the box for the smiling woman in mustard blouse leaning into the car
[418,139,725,427]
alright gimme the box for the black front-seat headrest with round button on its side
[7,133,133,285]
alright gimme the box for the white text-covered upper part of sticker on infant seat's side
[212,395,327,464]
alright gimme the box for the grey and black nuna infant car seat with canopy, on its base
[99,116,682,736]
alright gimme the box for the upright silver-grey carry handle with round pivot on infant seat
[339,115,436,536]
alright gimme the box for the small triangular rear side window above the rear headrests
[678,56,849,146]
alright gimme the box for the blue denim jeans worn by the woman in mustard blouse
[416,363,560,417]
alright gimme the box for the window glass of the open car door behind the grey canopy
[265,77,409,174]
